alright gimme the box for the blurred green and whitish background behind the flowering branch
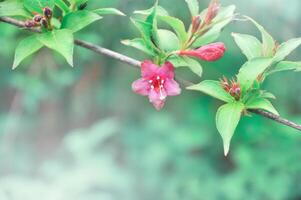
[0,0,301,200]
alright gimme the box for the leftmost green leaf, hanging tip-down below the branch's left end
[13,35,43,69]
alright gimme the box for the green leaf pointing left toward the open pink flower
[187,80,235,102]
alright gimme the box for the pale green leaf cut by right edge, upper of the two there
[273,38,301,63]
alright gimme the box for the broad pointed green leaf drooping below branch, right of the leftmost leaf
[38,29,74,66]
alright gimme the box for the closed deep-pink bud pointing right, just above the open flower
[179,42,226,61]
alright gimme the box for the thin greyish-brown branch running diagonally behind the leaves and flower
[0,17,301,131]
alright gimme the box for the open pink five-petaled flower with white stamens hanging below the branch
[132,60,181,110]
